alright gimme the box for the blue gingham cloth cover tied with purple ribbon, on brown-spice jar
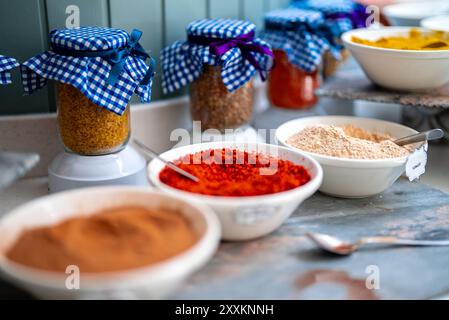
[160,19,271,93]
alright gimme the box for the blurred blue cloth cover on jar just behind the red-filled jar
[292,0,355,36]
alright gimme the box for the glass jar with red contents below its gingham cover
[268,50,320,109]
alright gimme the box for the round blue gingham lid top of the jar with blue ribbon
[50,27,129,51]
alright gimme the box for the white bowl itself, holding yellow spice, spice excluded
[342,27,449,91]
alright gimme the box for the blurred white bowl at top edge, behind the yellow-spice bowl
[383,0,449,27]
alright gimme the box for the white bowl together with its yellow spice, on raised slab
[342,27,449,91]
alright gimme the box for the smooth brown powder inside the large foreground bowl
[6,207,197,273]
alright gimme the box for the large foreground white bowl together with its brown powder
[0,187,220,299]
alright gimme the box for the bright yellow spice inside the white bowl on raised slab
[352,29,449,50]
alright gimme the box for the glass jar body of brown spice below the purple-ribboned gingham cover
[190,65,254,131]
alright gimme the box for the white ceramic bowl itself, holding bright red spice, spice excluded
[148,142,323,241]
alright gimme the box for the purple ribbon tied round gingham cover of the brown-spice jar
[188,31,274,81]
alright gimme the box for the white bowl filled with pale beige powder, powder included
[276,116,424,198]
